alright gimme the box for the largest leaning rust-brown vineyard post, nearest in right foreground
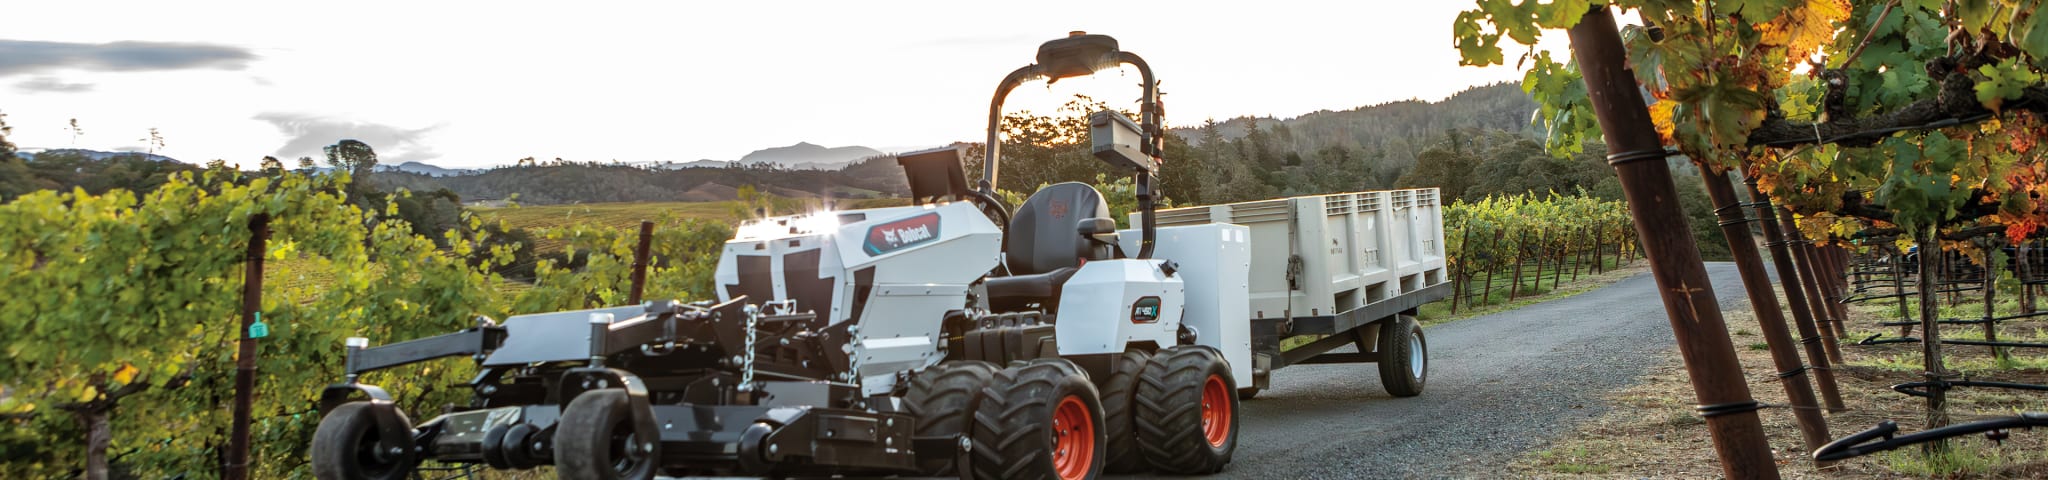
[1571,6,1778,480]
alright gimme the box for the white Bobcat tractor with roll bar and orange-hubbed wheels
[715,33,1251,478]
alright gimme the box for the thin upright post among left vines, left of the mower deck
[223,213,270,480]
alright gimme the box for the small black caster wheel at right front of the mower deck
[555,388,662,480]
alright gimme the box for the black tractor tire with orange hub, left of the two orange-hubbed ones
[967,359,1106,480]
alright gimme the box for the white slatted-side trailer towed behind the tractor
[1124,189,1450,398]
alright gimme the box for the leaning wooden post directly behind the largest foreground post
[1700,166,1829,451]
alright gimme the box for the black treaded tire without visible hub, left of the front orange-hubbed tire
[903,361,995,476]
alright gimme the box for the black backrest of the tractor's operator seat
[1004,183,1110,275]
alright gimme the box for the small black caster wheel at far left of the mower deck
[311,402,418,480]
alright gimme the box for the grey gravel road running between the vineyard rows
[1130,263,1743,478]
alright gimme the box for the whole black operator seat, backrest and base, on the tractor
[987,183,1116,312]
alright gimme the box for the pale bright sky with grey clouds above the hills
[0,0,1565,166]
